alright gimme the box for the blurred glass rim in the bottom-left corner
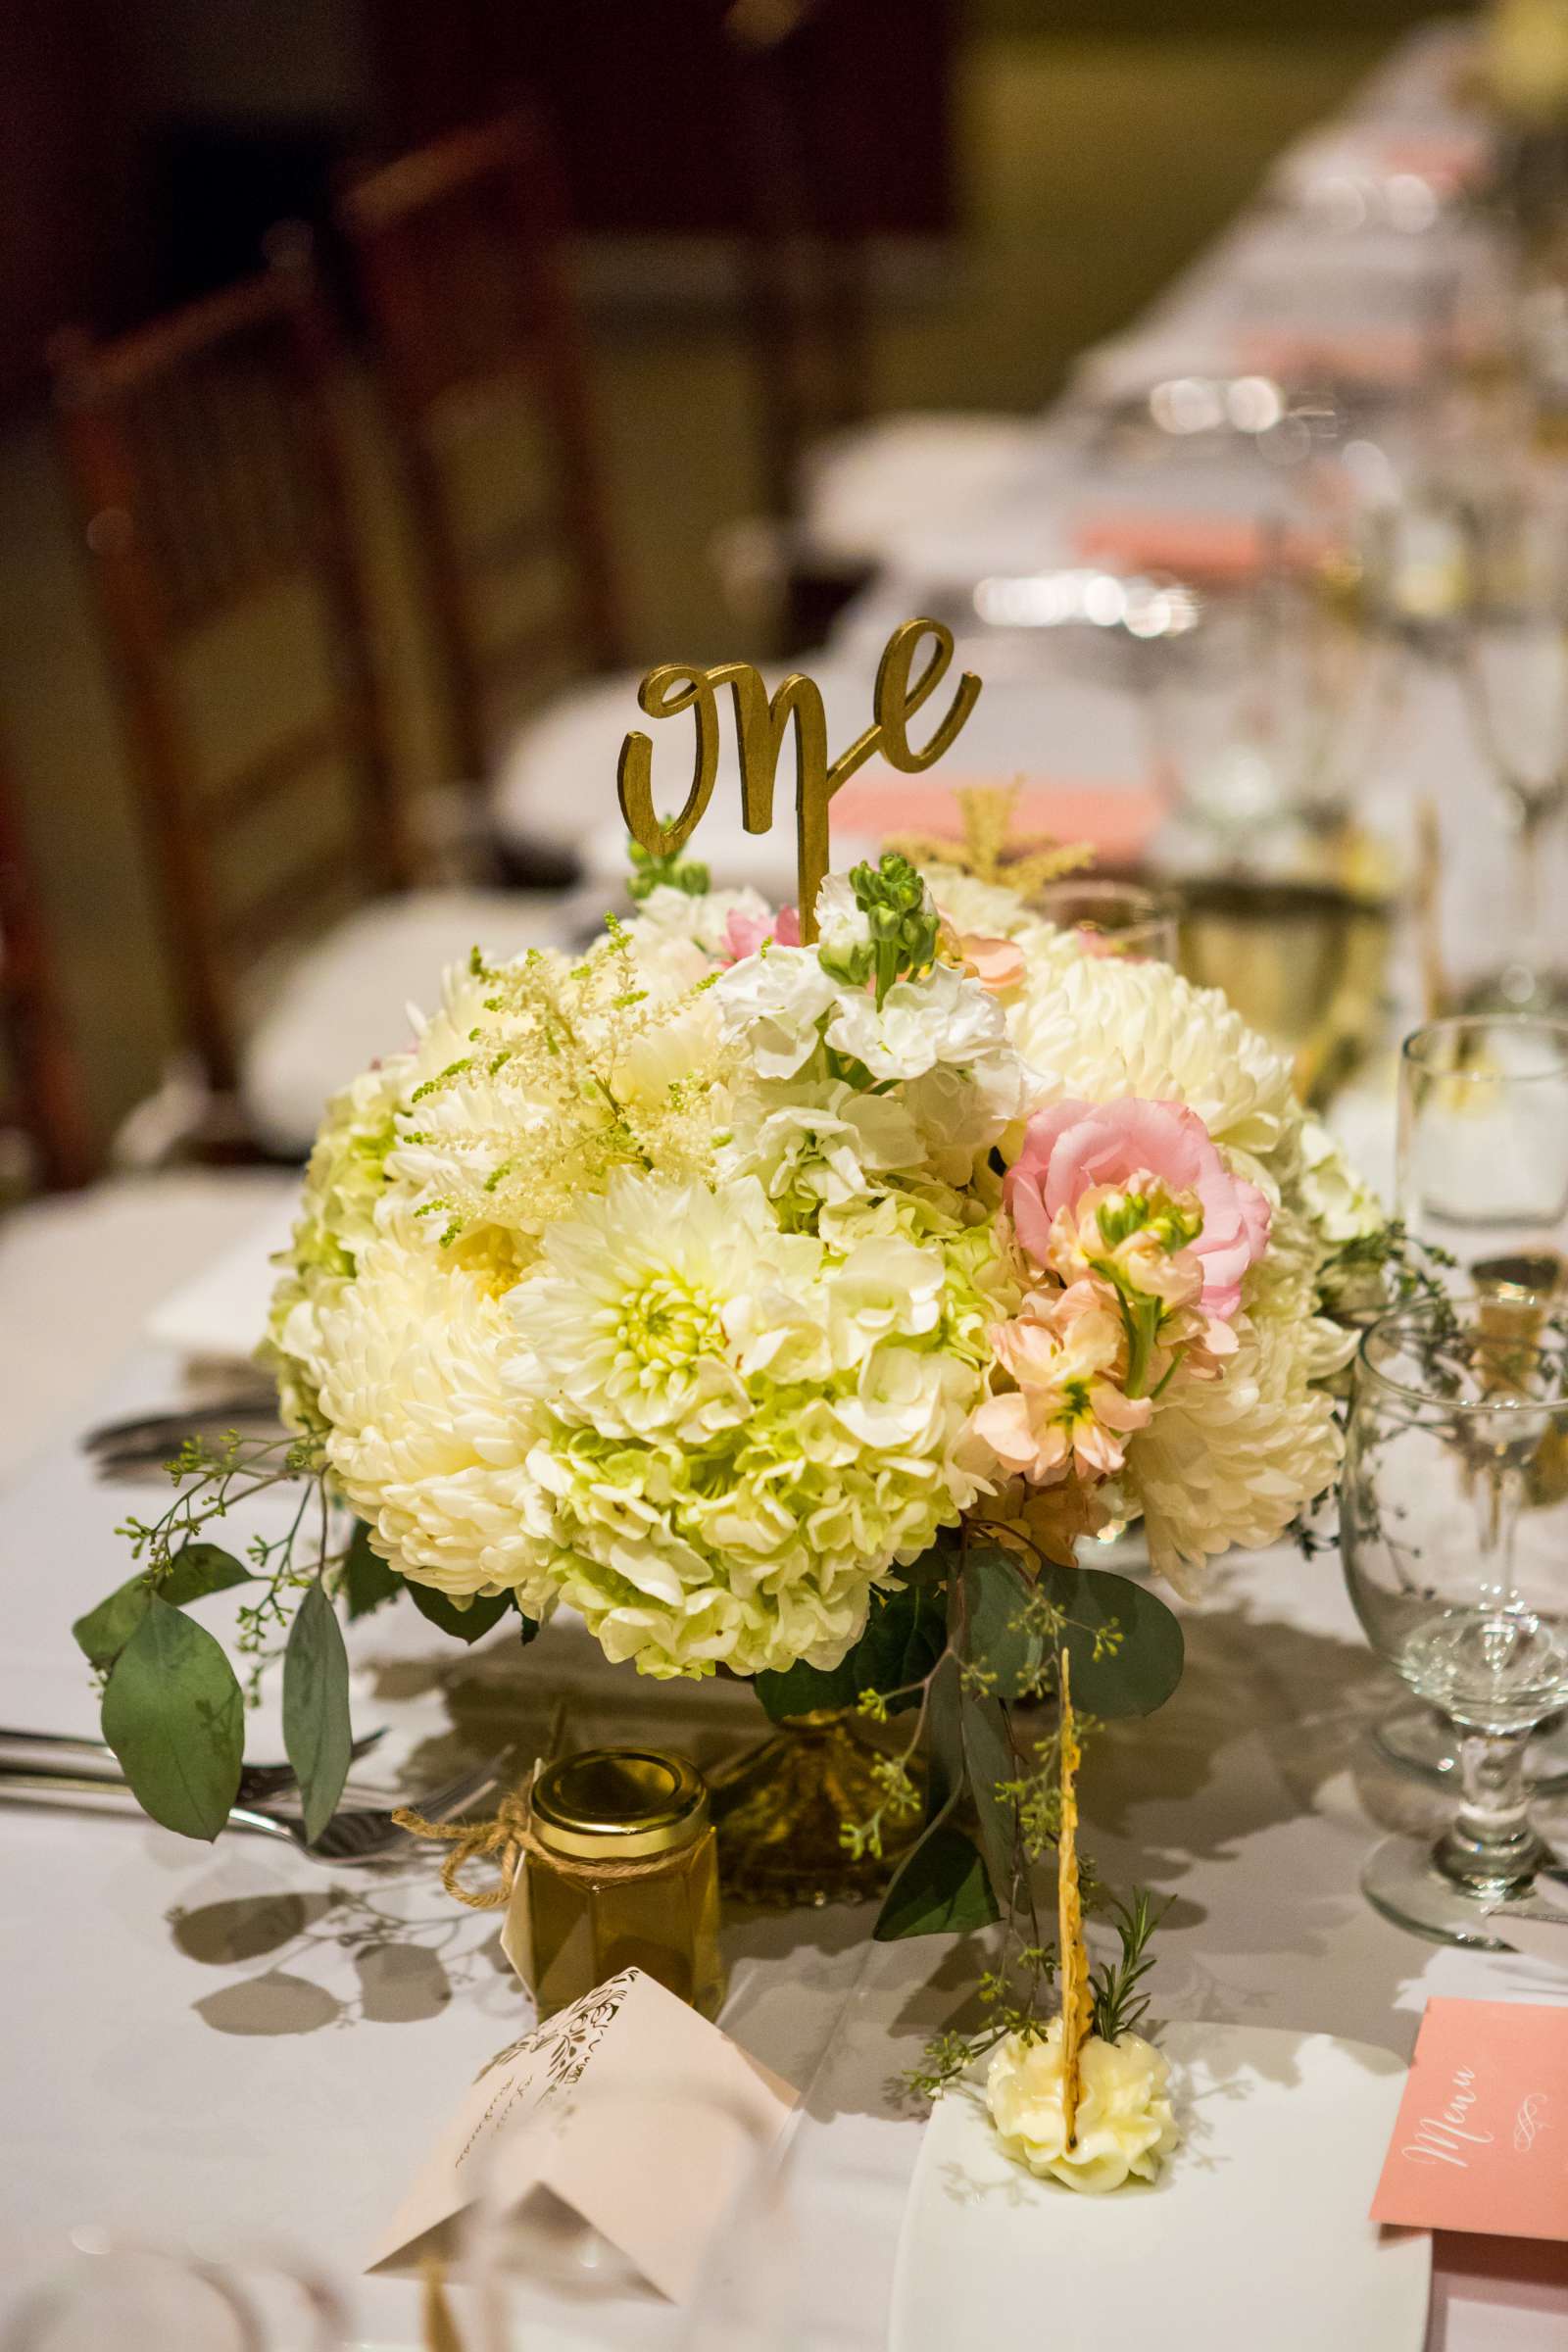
[0,2228,353,2352]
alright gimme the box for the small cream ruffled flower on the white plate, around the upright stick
[985,2018,1180,2194]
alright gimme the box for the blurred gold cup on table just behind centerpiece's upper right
[1178,875,1390,1107]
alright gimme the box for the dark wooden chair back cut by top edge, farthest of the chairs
[724,0,870,519]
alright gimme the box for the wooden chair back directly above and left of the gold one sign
[341,113,620,790]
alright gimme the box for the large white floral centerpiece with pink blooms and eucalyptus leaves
[77,857,1387,1966]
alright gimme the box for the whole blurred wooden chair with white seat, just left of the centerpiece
[52,233,570,1157]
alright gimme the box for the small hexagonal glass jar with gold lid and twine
[524,1747,724,2018]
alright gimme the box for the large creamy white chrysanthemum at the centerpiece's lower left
[319,1211,553,1616]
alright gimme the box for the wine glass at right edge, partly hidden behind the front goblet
[1378,1013,1568,1789]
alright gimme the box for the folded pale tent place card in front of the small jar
[367,1969,797,2303]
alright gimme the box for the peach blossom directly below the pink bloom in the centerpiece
[973,1282,1154,1487]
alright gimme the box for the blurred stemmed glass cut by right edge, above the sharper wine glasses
[1460,470,1568,1013]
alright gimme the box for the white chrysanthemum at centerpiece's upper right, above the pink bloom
[1008,955,1300,1169]
